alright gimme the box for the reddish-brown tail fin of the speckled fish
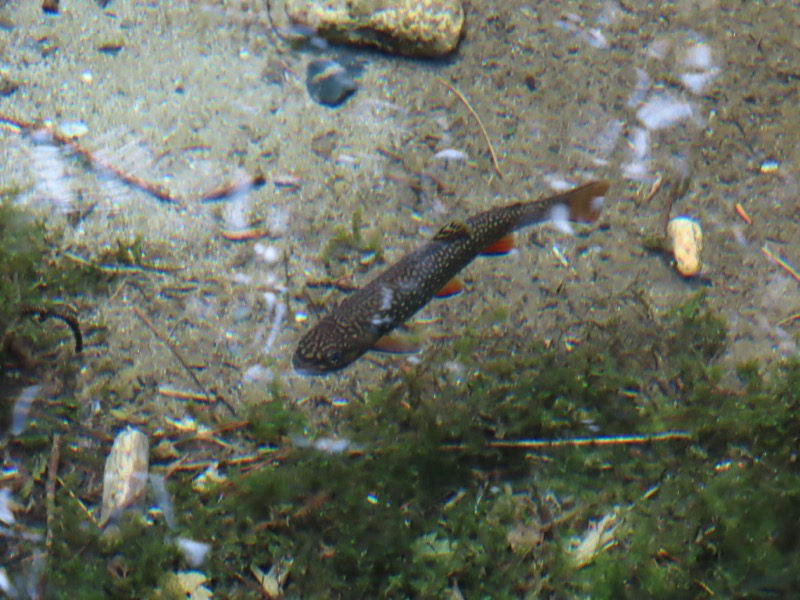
[516,180,609,233]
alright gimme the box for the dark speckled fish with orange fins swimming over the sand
[292,180,609,375]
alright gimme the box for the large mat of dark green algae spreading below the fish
[8,252,800,598]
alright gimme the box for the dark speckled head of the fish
[292,320,369,375]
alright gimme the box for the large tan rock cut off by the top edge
[286,0,464,57]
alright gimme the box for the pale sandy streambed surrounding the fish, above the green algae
[0,0,800,597]
